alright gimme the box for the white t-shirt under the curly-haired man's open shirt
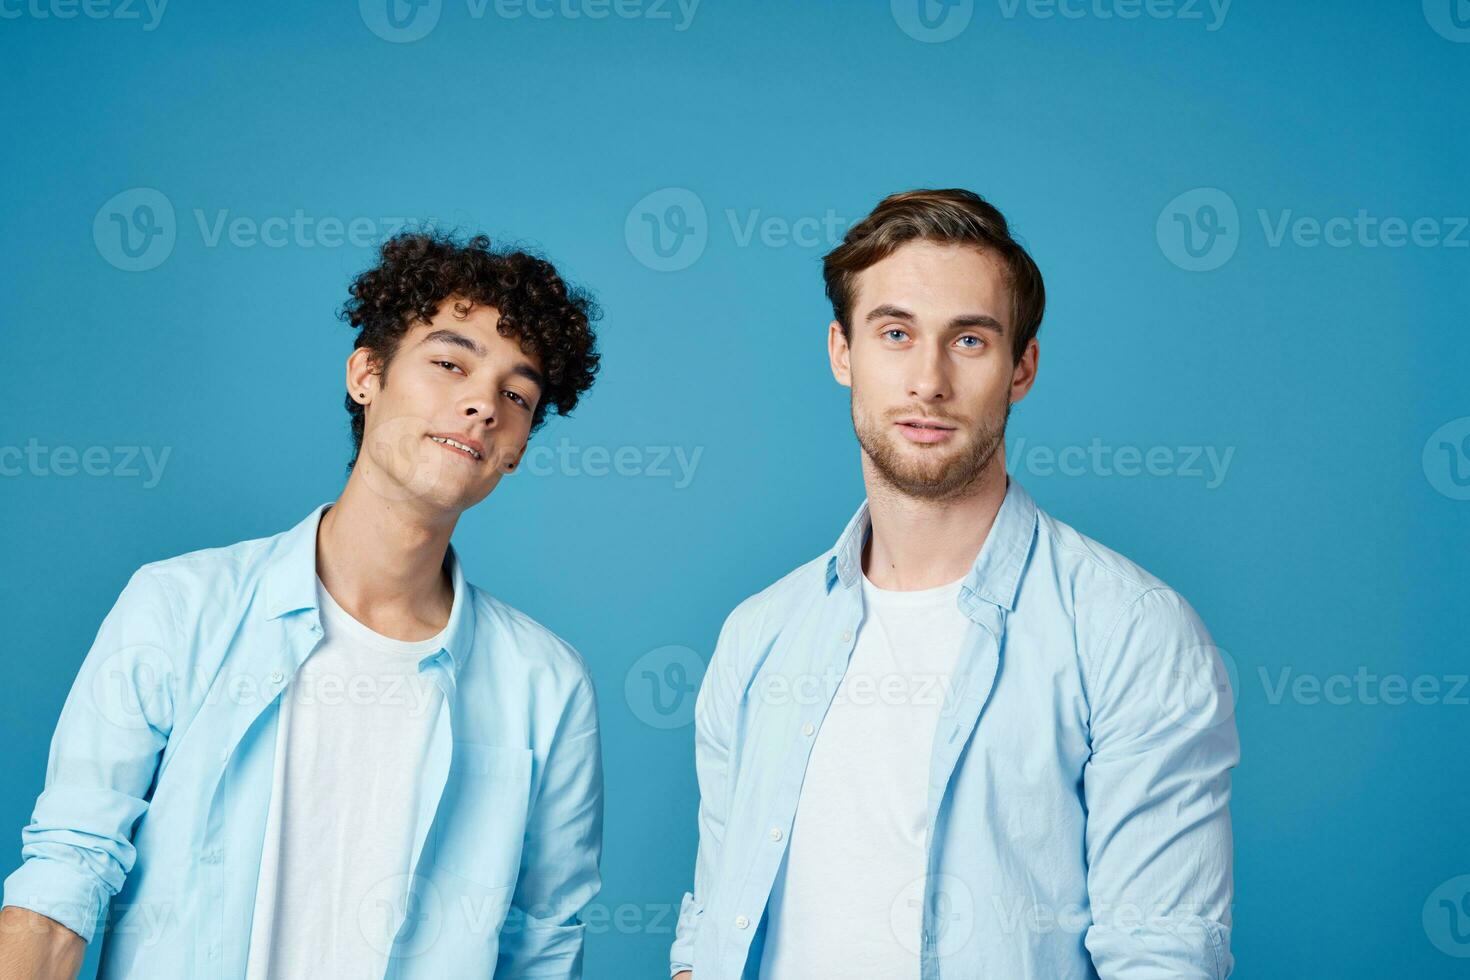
[245,579,448,980]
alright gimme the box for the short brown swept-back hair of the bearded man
[822,188,1047,361]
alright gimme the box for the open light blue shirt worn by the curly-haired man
[4,504,603,980]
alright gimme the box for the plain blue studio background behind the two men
[0,0,1470,979]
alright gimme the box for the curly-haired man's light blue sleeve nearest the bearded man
[495,674,603,980]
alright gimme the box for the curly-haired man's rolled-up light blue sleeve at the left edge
[4,567,179,942]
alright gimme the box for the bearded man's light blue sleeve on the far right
[1083,588,1239,980]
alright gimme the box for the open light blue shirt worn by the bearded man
[670,480,1239,980]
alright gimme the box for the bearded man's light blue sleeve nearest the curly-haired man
[669,608,741,976]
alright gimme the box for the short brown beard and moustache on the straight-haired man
[851,397,1011,501]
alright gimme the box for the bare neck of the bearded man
[863,444,1005,591]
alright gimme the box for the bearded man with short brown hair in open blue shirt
[670,190,1239,980]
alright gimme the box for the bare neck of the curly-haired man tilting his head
[316,470,459,641]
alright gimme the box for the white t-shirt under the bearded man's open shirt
[760,574,970,980]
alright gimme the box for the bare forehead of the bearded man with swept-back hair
[853,239,1010,323]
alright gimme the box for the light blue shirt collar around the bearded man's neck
[826,478,1036,611]
